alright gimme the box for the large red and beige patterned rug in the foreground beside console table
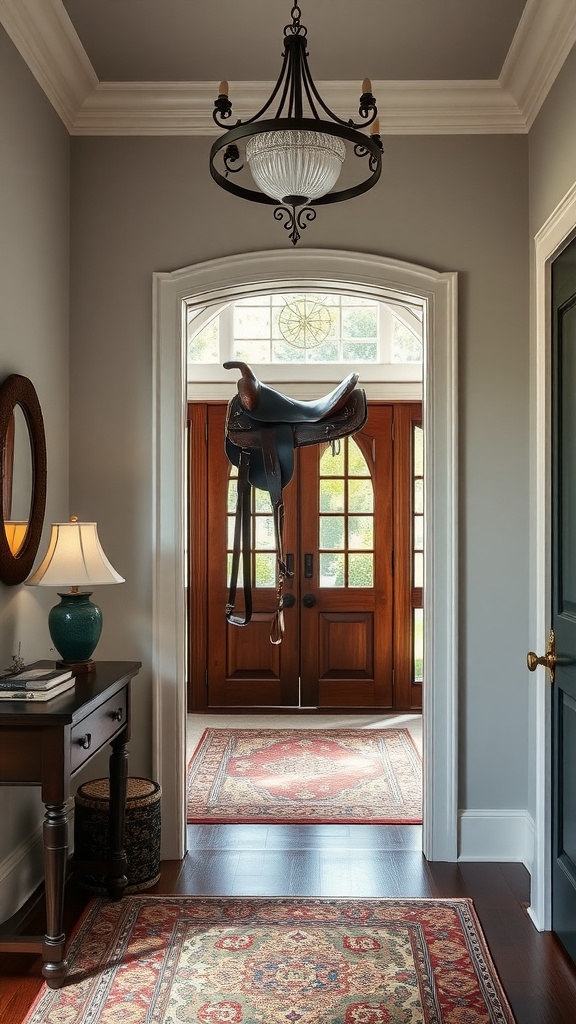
[25,896,513,1024]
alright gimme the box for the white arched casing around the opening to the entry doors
[152,249,458,861]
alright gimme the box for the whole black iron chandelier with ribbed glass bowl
[210,5,382,245]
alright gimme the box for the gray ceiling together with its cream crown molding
[0,0,576,135]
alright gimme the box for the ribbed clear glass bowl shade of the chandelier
[246,129,346,206]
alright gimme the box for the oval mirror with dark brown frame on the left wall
[0,374,46,586]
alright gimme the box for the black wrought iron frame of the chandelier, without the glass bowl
[210,5,383,245]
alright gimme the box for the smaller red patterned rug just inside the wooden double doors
[188,729,422,824]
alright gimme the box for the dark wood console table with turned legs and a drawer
[0,662,140,988]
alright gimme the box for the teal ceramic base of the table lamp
[48,593,102,672]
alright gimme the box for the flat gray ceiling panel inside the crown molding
[59,0,526,83]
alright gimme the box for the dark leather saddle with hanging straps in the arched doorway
[223,360,368,643]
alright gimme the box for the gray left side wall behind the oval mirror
[0,30,70,920]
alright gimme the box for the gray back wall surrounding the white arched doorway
[71,136,529,809]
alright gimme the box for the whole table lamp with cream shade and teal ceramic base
[26,516,124,672]
